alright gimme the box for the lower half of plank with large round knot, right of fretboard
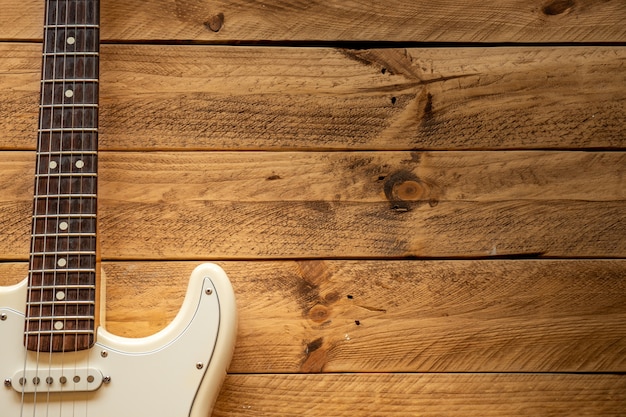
[100,200,626,259]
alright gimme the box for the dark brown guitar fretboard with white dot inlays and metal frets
[25,0,99,352]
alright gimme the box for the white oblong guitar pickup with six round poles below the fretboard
[7,368,105,394]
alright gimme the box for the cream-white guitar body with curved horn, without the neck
[0,264,236,417]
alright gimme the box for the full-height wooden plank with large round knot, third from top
[0,152,626,259]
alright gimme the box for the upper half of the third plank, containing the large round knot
[6,151,626,205]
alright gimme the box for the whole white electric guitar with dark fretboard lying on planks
[0,0,236,417]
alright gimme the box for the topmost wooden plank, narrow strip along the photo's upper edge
[0,0,626,43]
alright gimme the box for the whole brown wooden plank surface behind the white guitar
[0,0,626,417]
